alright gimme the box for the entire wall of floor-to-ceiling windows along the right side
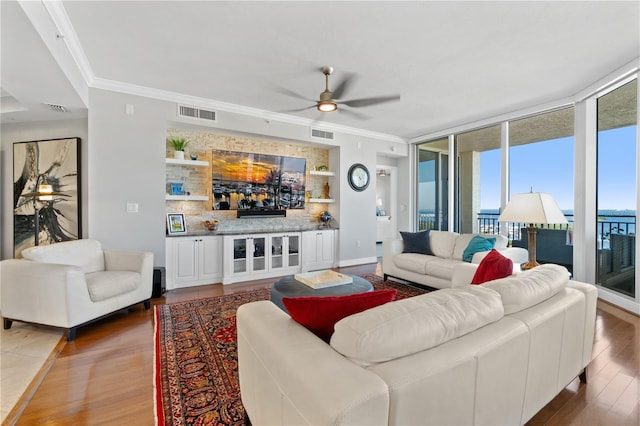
[418,69,640,313]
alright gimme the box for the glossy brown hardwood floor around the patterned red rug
[7,264,640,425]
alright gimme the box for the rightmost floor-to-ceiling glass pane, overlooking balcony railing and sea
[596,80,638,298]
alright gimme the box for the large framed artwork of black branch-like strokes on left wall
[13,138,82,257]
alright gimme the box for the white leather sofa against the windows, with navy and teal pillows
[382,231,529,289]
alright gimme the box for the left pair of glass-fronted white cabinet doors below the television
[222,234,269,284]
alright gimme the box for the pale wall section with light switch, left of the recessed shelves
[87,89,170,266]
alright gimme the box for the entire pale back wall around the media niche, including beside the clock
[88,89,408,266]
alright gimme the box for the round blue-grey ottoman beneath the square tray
[271,274,373,313]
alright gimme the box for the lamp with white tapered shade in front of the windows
[498,192,568,270]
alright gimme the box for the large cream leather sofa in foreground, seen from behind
[237,265,597,425]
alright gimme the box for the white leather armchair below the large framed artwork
[0,239,153,341]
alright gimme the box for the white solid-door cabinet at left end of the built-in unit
[166,235,222,289]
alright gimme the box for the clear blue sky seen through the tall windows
[480,126,636,210]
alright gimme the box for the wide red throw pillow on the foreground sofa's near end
[282,289,397,342]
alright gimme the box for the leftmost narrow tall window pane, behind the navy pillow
[417,139,449,231]
